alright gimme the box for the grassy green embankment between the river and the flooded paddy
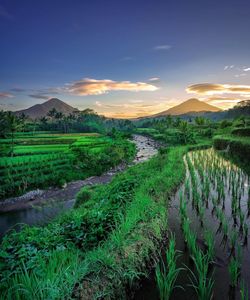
[1,148,186,299]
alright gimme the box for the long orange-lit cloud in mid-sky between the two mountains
[65,78,158,96]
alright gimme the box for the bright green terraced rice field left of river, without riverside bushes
[0,132,128,198]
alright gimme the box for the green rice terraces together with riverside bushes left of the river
[0,133,135,198]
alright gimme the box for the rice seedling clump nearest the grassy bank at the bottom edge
[155,237,183,300]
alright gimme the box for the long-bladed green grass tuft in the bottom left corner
[0,250,84,300]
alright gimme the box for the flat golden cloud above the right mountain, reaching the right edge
[186,83,250,95]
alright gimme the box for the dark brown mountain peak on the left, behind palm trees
[15,98,78,119]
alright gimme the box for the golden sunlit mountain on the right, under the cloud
[150,98,221,117]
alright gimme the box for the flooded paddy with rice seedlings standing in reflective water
[133,149,250,300]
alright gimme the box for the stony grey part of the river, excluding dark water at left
[0,135,158,213]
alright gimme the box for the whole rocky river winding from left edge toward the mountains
[0,135,158,235]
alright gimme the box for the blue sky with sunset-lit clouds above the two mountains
[0,0,250,118]
